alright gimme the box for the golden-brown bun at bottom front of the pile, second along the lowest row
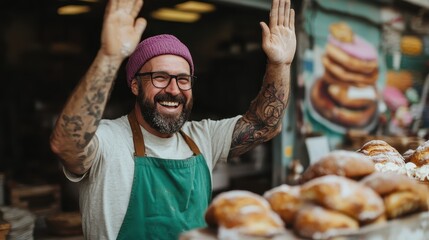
[293,205,359,239]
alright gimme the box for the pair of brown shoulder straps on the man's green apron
[128,109,201,157]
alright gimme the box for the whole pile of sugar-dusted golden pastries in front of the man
[205,140,429,239]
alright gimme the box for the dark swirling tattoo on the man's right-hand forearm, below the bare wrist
[230,84,287,156]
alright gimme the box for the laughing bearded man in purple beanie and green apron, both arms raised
[51,0,296,239]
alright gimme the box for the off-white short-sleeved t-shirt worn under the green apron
[64,116,241,240]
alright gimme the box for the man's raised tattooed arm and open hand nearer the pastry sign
[229,0,296,157]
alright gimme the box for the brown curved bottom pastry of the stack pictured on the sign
[310,79,377,127]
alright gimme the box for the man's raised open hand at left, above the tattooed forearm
[100,0,147,60]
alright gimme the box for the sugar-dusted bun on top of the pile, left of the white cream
[301,150,375,183]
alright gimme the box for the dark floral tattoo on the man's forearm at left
[59,62,116,170]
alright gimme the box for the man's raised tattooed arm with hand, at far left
[50,0,146,174]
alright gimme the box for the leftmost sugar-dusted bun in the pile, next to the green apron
[205,190,285,239]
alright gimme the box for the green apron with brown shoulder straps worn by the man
[117,111,211,240]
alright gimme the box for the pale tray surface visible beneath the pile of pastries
[180,212,429,240]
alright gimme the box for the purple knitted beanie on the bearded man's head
[125,34,194,87]
